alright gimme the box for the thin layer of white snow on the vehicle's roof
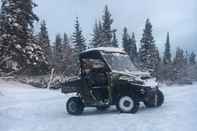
[84,47,125,53]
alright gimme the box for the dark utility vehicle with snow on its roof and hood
[62,47,164,115]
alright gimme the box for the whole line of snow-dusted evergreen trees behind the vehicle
[0,0,197,81]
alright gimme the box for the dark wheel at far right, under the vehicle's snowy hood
[144,90,164,107]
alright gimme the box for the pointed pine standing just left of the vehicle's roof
[72,17,86,53]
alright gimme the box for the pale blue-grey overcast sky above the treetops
[34,0,197,53]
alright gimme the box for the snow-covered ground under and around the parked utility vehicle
[0,80,197,131]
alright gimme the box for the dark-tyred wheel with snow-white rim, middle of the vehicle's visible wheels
[116,96,139,113]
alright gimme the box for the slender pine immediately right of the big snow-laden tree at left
[39,20,52,63]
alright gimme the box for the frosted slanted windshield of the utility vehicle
[103,53,139,72]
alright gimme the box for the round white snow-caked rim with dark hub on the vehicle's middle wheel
[119,96,134,112]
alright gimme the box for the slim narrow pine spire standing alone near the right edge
[163,32,172,64]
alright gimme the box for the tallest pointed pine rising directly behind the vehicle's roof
[101,6,114,47]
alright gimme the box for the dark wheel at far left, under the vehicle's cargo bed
[66,97,84,115]
